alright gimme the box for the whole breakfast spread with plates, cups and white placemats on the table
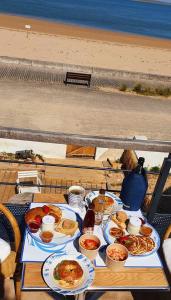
[21,186,162,295]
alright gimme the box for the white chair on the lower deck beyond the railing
[17,171,42,193]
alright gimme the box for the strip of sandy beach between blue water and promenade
[0,14,171,76]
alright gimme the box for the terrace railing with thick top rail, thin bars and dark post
[0,127,171,236]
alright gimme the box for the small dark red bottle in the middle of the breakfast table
[82,203,95,234]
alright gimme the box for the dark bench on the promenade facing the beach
[64,72,91,87]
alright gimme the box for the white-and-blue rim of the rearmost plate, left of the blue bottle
[85,191,123,210]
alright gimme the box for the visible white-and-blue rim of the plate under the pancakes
[103,221,160,257]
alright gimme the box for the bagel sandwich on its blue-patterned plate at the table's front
[42,253,95,296]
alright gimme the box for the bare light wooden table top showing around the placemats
[23,194,169,290]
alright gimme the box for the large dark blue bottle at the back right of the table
[120,157,148,211]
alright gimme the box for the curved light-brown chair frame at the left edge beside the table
[0,203,21,299]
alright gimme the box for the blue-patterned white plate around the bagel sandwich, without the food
[42,253,95,295]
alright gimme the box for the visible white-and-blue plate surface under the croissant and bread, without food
[28,204,81,248]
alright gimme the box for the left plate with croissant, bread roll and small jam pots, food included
[25,204,82,248]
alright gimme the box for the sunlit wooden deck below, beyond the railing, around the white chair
[0,158,108,203]
